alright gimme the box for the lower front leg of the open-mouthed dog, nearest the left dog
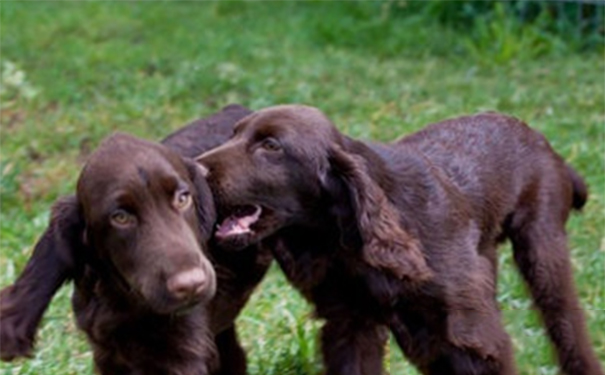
[321,316,388,375]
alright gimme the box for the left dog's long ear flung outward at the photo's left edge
[0,196,84,361]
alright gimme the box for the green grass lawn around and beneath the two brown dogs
[0,1,605,375]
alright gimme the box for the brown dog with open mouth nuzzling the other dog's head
[198,105,603,375]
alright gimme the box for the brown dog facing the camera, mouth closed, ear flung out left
[0,106,271,375]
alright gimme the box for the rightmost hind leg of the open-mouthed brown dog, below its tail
[510,210,603,375]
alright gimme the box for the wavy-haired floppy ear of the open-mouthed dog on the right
[327,147,432,281]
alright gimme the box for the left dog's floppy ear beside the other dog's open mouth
[183,158,216,239]
